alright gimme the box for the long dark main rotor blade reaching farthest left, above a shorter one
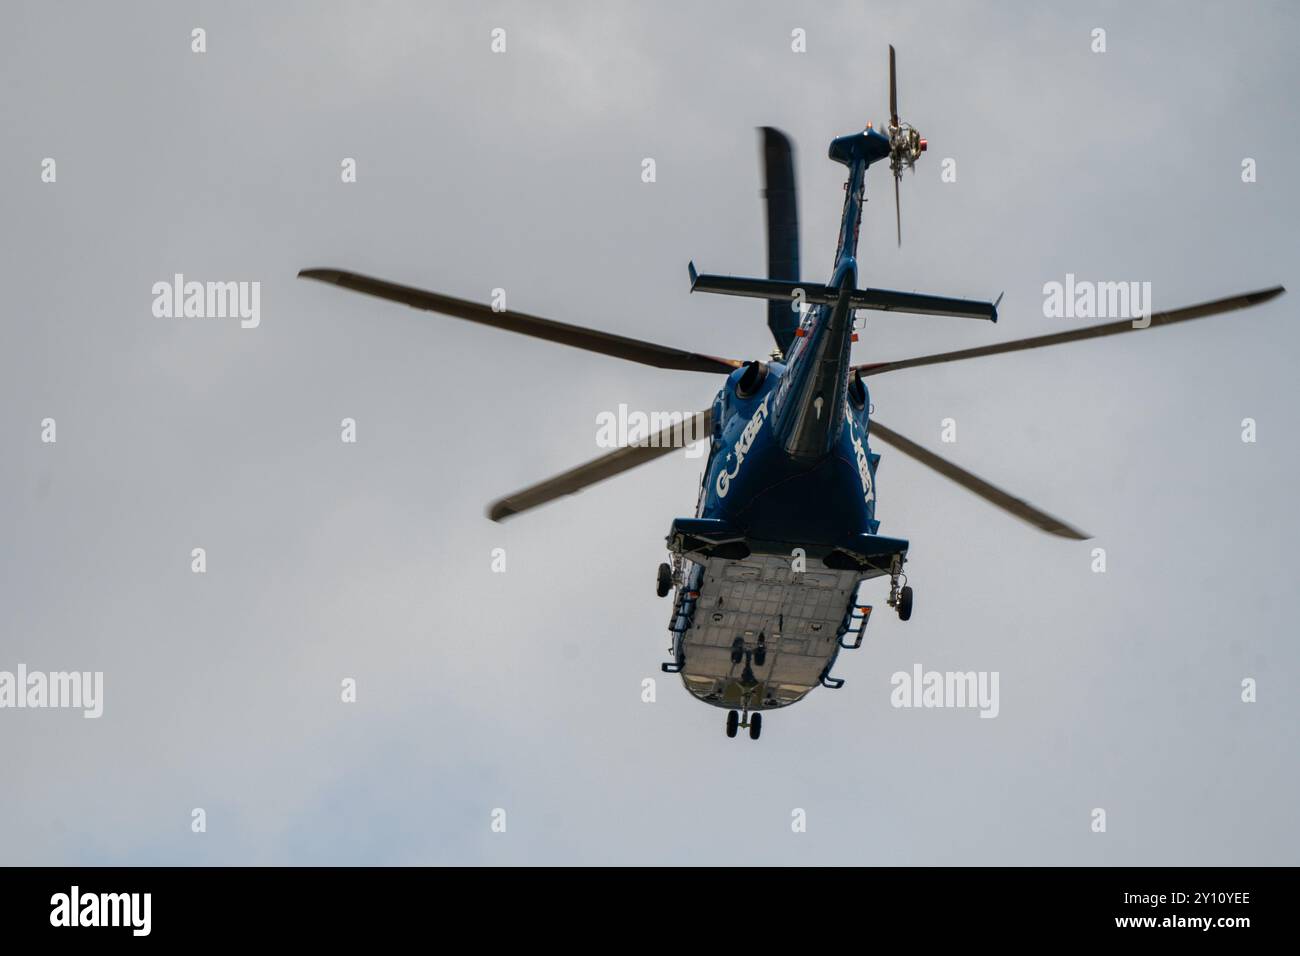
[298,269,744,375]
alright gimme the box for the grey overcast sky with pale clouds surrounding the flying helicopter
[0,3,1300,865]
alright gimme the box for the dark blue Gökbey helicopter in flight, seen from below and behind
[298,46,1284,740]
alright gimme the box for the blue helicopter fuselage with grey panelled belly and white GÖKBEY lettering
[666,287,907,721]
